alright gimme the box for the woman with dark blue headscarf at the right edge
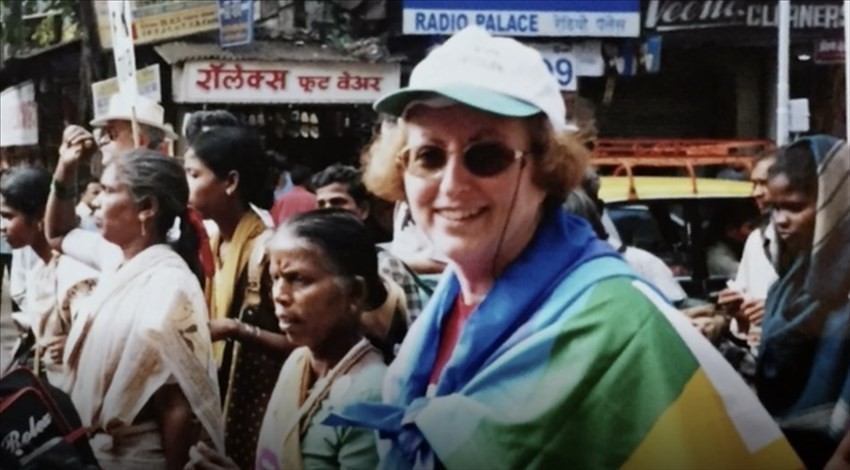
[756,136,850,468]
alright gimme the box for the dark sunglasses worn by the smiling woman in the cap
[398,142,529,178]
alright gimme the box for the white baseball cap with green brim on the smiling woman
[375,26,576,131]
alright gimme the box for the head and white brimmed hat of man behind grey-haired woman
[91,93,178,165]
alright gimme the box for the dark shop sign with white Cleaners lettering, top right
[644,0,844,32]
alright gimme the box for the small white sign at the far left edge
[0,81,38,147]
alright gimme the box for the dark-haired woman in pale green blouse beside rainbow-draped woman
[187,209,386,470]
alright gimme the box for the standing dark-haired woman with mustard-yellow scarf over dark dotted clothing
[184,127,291,468]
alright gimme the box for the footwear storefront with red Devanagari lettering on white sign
[156,42,400,170]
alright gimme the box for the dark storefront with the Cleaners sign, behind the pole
[579,0,844,139]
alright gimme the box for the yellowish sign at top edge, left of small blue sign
[94,0,218,49]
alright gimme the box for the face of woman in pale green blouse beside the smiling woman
[269,231,360,350]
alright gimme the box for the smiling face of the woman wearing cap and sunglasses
[404,105,545,268]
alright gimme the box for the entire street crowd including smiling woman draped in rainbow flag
[0,27,850,470]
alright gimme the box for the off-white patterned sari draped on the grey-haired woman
[63,245,224,469]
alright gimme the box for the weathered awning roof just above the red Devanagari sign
[154,41,401,65]
